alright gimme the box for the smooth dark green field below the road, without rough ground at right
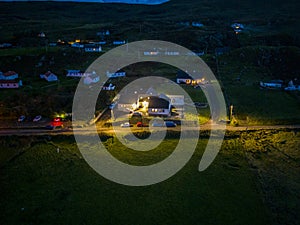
[0,134,270,225]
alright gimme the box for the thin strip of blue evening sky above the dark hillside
[0,0,169,5]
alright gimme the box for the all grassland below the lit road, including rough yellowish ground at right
[0,131,300,225]
